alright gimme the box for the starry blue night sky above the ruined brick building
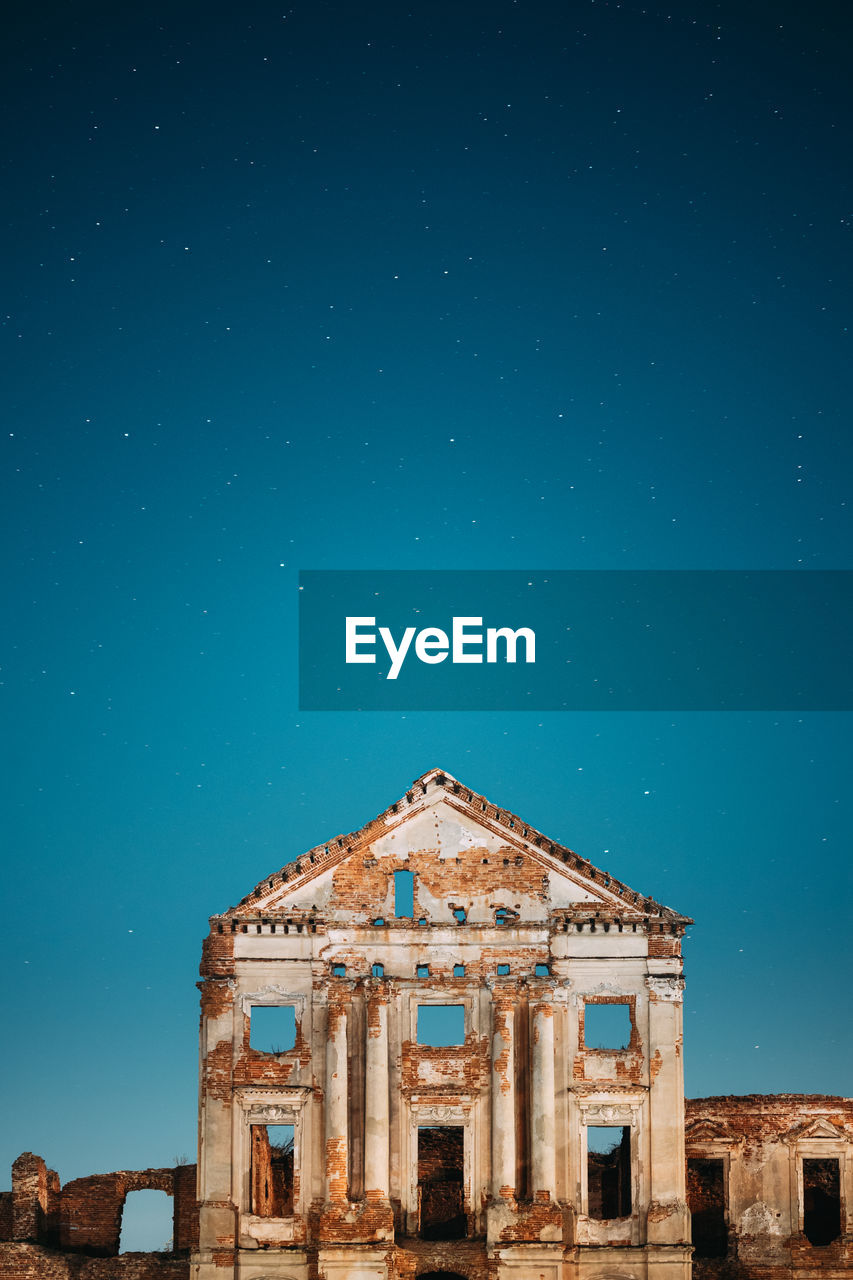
[0,0,853,1208]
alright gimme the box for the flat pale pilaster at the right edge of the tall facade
[646,974,689,1244]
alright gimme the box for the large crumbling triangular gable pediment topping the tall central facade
[228,769,689,927]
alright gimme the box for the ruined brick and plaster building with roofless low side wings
[0,771,853,1280]
